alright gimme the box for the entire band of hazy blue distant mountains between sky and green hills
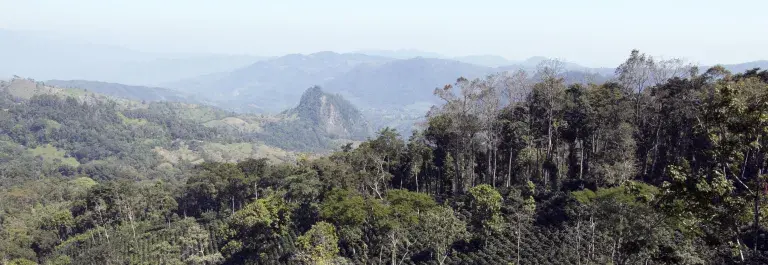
[0,30,768,134]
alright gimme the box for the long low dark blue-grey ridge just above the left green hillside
[45,80,202,103]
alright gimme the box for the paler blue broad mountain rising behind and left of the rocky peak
[167,52,392,112]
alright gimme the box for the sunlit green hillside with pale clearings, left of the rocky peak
[0,78,366,189]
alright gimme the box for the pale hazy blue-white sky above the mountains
[0,0,768,67]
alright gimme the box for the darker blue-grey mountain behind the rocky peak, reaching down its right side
[323,57,494,136]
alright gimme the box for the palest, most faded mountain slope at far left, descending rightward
[0,29,264,86]
